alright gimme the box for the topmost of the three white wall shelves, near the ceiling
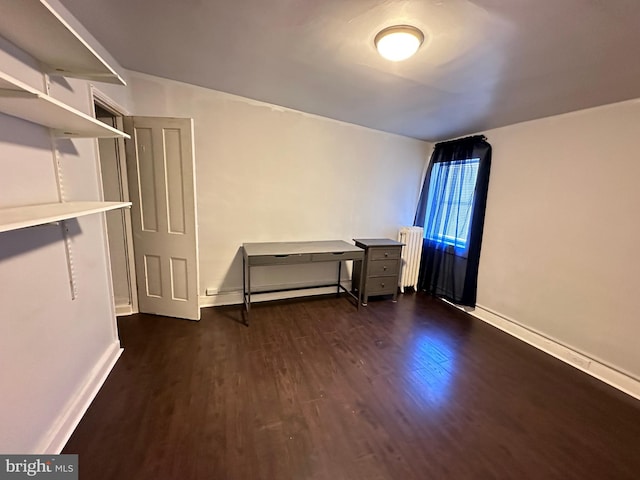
[0,0,126,85]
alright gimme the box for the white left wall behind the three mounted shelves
[0,14,126,453]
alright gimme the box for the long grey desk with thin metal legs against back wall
[242,240,364,324]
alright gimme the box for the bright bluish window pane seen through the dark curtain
[424,158,480,249]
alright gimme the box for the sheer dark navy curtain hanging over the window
[414,135,491,307]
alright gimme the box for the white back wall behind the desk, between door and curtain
[129,72,431,301]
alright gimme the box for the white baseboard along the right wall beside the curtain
[460,302,640,400]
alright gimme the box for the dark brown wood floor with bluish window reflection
[64,294,640,480]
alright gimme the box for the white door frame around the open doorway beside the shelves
[90,85,139,316]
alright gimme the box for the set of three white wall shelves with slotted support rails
[0,0,131,300]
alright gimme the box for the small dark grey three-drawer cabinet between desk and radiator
[351,238,404,305]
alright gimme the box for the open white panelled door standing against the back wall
[125,117,200,320]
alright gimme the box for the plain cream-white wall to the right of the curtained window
[478,100,640,380]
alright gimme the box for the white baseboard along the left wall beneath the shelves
[34,340,123,454]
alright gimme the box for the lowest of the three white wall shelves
[0,202,131,232]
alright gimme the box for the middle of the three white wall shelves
[0,71,130,138]
